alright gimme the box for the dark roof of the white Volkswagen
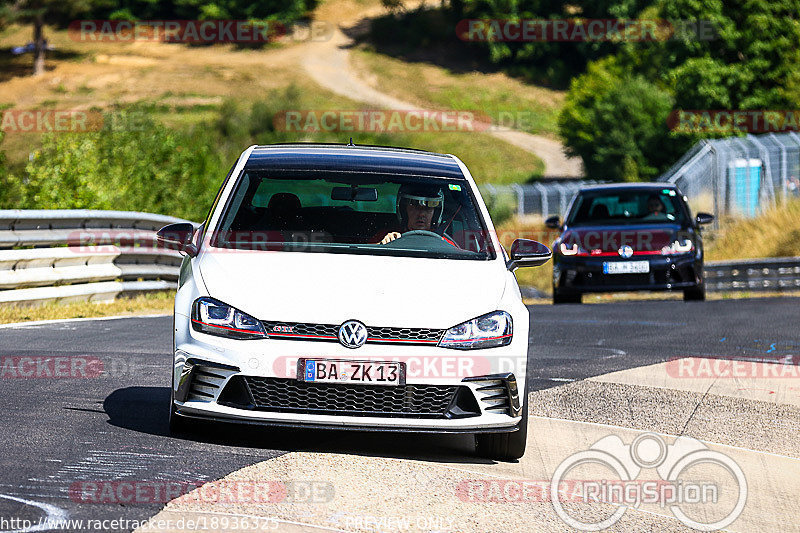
[245,143,464,180]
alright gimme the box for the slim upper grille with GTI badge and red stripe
[261,320,445,344]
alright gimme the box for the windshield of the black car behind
[567,189,686,226]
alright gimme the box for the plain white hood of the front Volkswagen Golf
[199,250,505,329]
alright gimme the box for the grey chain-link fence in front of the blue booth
[659,132,800,222]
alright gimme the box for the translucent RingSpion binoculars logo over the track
[550,433,747,531]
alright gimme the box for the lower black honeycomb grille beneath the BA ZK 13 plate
[226,376,466,418]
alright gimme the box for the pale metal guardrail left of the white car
[0,209,192,305]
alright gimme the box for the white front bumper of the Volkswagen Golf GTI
[173,315,527,433]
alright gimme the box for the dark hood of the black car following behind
[557,224,693,253]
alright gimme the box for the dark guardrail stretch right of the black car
[704,257,800,291]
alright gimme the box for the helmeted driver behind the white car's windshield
[380,184,444,244]
